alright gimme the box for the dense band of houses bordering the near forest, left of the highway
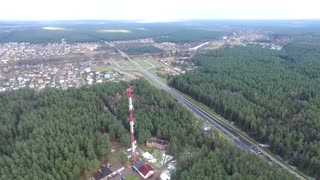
[0,62,126,92]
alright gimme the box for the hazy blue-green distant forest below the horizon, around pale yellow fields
[0,21,221,43]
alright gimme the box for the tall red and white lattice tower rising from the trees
[127,85,137,163]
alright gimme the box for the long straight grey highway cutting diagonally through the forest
[106,42,307,179]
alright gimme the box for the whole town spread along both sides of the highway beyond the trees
[0,32,281,92]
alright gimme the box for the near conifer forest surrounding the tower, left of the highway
[0,80,294,180]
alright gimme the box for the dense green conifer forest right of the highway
[169,44,320,179]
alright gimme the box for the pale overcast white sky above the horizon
[0,0,320,21]
